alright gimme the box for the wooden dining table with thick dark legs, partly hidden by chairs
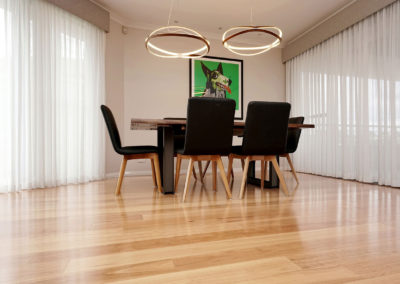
[131,118,314,194]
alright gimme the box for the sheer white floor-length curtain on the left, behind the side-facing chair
[0,0,105,192]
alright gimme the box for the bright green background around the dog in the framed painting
[193,59,239,110]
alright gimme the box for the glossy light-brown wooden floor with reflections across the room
[0,172,400,284]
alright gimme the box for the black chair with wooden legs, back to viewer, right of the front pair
[228,102,290,198]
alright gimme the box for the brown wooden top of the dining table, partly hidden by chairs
[131,118,315,130]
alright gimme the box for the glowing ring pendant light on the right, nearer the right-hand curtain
[222,26,282,56]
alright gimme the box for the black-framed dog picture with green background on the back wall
[189,56,243,119]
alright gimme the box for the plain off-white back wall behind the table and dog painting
[106,21,285,173]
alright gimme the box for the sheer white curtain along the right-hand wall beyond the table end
[286,1,400,187]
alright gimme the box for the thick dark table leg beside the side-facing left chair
[157,127,174,194]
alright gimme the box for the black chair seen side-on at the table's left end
[100,105,162,195]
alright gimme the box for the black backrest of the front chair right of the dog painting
[242,102,290,155]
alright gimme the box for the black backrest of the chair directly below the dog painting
[183,97,236,155]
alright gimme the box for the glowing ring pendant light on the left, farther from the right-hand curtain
[145,26,210,58]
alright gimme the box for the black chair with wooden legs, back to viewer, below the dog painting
[175,97,235,201]
